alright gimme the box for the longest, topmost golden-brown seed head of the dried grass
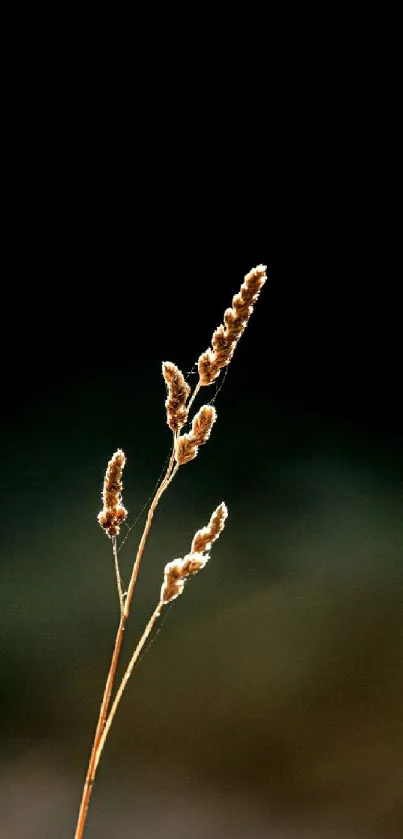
[197,265,267,385]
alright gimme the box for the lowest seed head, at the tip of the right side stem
[160,502,228,603]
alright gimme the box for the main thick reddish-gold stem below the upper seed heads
[74,449,175,839]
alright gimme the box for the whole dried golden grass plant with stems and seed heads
[75,265,266,839]
